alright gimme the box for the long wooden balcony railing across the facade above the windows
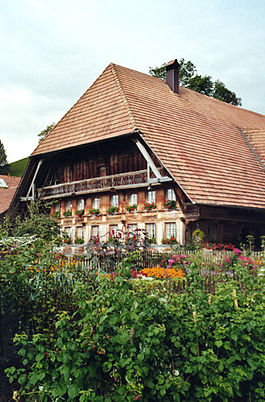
[37,170,157,200]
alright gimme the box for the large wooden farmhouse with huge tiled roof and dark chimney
[10,60,265,244]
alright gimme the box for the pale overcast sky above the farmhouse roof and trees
[0,0,265,162]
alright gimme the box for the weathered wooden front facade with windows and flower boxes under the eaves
[34,138,186,244]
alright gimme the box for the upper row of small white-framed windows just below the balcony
[55,188,176,211]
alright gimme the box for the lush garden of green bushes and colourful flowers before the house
[0,207,265,402]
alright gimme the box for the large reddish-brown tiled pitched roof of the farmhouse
[32,64,265,208]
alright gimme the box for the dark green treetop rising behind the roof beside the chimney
[149,58,242,106]
